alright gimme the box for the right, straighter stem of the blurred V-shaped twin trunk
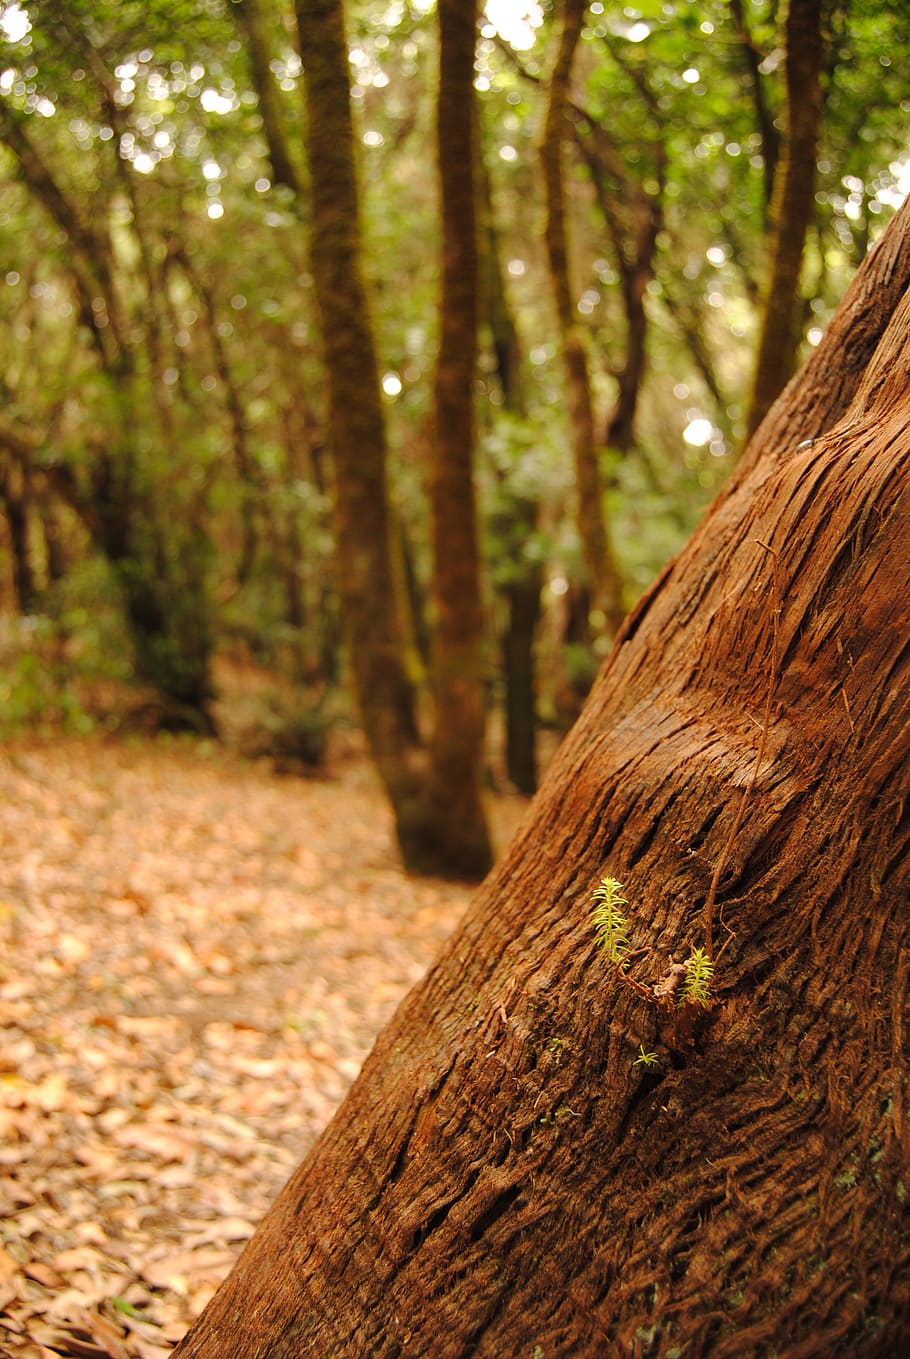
[429,0,493,877]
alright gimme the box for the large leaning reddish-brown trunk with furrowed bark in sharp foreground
[169,191,910,1359]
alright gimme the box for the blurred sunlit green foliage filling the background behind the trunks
[0,0,910,739]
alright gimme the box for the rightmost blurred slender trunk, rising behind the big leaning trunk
[747,0,824,434]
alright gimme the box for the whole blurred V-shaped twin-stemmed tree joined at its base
[297,0,492,878]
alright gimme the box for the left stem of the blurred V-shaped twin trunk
[296,0,421,831]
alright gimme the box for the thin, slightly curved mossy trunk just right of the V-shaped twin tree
[541,0,623,631]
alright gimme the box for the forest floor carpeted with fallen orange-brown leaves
[0,737,537,1359]
